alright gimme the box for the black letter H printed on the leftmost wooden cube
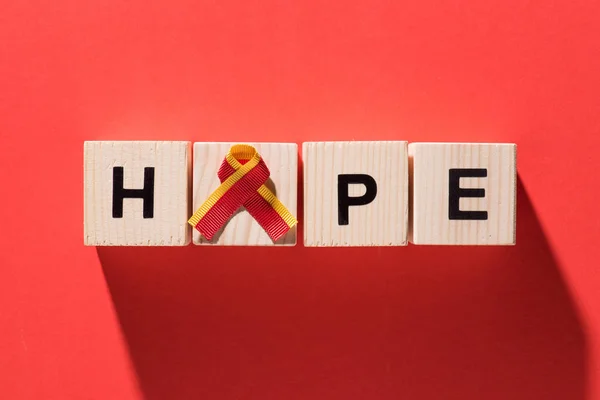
[113,167,154,218]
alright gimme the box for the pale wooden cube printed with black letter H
[84,141,191,246]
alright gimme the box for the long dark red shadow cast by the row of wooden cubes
[97,177,587,400]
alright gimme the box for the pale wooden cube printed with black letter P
[302,141,408,246]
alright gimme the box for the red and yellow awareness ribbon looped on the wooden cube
[188,144,298,241]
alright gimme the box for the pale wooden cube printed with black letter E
[408,143,517,245]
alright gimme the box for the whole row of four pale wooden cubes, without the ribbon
[84,141,516,246]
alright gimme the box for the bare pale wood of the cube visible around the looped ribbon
[193,142,298,246]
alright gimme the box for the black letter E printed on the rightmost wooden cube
[448,168,487,221]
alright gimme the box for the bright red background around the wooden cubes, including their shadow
[0,0,600,400]
